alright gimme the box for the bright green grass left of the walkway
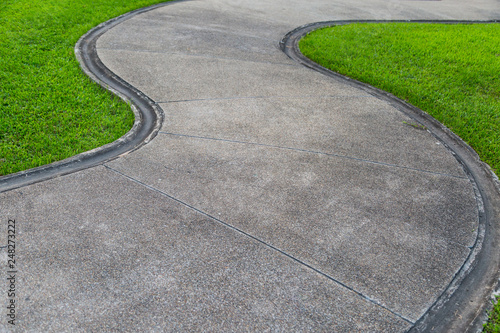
[0,0,169,176]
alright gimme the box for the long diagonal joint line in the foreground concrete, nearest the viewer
[104,164,415,325]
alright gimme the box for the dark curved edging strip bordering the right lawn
[280,20,500,332]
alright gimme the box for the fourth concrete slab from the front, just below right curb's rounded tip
[99,49,366,103]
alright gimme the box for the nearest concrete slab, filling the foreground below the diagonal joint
[0,167,409,332]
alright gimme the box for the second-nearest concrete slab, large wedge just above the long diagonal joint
[108,135,478,321]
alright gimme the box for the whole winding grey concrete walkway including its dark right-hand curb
[0,0,500,332]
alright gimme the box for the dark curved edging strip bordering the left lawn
[0,1,178,193]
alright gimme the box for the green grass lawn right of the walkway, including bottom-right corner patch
[299,23,500,332]
